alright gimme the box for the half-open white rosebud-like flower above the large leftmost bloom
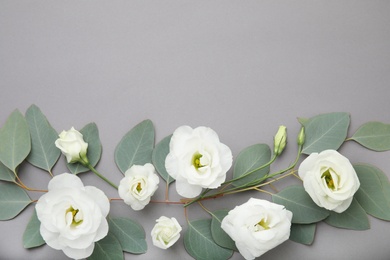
[55,127,88,163]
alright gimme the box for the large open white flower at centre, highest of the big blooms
[165,126,233,198]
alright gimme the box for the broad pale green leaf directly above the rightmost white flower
[302,112,350,154]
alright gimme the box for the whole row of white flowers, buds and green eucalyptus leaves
[0,105,390,259]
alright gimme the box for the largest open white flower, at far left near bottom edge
[35,173,110,259]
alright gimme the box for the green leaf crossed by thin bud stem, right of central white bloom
[233,144,271,186]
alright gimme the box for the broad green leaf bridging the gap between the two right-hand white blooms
[272,185,329,224]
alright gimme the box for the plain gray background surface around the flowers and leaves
[0,0,390,260]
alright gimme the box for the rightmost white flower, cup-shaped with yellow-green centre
[298,150,360,213]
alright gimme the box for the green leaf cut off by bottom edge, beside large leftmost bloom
[88,232,124,260]
